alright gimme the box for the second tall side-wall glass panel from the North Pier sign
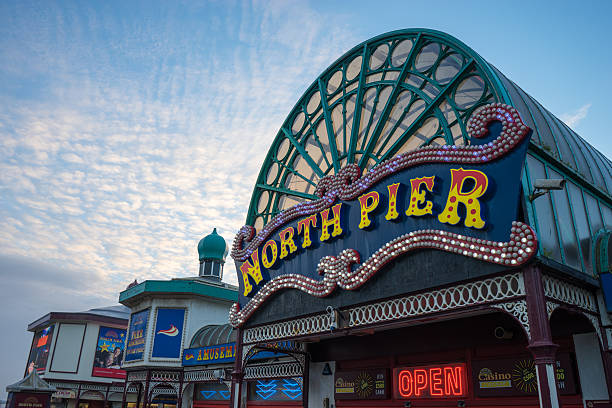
[540,168,582,269]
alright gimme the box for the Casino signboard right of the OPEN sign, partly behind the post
[472,353,576,397]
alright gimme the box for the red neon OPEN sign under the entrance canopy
[393,363,467,399]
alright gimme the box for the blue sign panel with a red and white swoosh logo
[151,309,185,358]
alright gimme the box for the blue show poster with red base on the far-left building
[91,326,126,378]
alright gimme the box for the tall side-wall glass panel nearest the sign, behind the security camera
[527,155,562,262]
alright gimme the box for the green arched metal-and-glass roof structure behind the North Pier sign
[246,29,612,273]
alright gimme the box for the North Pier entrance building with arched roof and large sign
[230,29,612,408]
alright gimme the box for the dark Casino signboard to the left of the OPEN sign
[334,368,389,400]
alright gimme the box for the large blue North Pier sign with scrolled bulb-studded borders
[230,104,537,326]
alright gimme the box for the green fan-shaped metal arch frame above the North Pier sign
[246,29,512,229]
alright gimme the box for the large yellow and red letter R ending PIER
[438,169,489,229]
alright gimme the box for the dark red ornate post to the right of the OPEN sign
[523,265,559,408]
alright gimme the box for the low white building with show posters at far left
[25,305,135,408]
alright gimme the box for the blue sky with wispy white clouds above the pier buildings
[0,0,612,399]
